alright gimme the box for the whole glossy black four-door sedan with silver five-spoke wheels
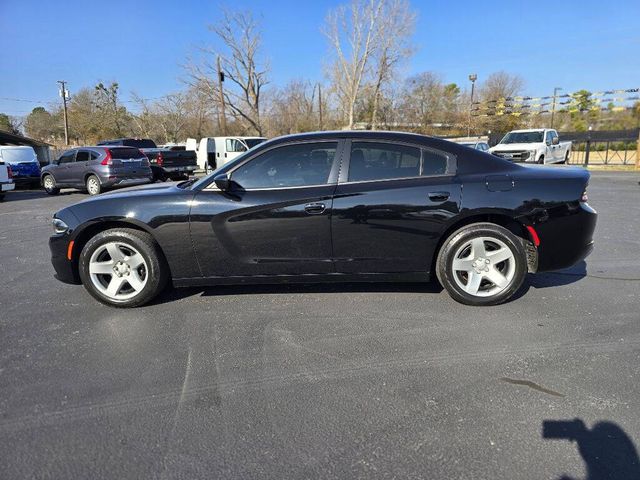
[50,132,596,307]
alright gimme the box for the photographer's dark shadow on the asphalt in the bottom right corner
[542,418,640,480]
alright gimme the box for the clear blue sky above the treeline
[0,0,640,115]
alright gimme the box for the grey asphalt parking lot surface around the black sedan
[0,172,640,479]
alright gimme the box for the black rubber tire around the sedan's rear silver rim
[436,223,527,306]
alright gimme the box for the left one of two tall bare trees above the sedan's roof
[323,0,385,128]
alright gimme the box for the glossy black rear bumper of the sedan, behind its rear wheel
[534,203,598,272]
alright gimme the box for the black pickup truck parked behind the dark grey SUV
[98,138,197,182]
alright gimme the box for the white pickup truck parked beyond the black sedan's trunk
[489,128,571,163]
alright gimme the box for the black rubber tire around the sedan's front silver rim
[78,228,169,308]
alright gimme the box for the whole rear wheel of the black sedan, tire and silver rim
[436,223,527,305]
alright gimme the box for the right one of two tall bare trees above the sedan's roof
[371,0,416,129]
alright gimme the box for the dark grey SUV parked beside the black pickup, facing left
[41,146,152,195]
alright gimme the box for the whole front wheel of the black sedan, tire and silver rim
[79,228,168,307]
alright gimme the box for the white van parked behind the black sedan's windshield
[187,137,267,172]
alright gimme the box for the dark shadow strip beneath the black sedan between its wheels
[149,282,442,305]
